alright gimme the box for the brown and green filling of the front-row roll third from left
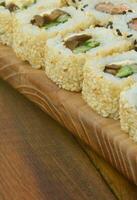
[64,34,100,54]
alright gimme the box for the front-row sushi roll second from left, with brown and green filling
[13,6,93,68]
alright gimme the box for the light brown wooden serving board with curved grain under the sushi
[0,46,137,185]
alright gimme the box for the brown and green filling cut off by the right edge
[104,63,137,78]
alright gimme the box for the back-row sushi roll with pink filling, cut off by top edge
[80,0,137,26]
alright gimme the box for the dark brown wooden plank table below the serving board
[0,80,137,200]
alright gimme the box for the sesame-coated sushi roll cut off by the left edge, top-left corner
[0,0,38,46]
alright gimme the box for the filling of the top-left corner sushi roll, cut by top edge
[0,0,36,12]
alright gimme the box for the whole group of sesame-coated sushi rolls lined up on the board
[0,0,137,141]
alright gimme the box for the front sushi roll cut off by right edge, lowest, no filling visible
[120,84,137,142]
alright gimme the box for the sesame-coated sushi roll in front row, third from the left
[45,28,131,92]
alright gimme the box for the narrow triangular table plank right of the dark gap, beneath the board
[79,141,137,200]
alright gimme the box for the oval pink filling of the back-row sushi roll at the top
[95,2,131,15]
